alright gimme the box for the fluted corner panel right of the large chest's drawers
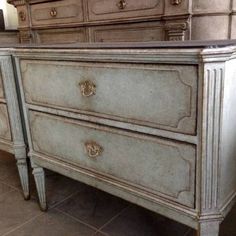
[202,64,224,212]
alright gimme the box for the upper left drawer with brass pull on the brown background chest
[30,0,84,26]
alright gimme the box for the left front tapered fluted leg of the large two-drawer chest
[33,165,47,211]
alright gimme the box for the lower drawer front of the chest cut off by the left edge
[0,103,11,141]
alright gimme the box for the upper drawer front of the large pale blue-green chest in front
[21,60,197,134]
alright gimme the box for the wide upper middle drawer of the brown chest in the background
[88,0,164,21]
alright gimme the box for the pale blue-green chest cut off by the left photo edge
[0,49,29,199]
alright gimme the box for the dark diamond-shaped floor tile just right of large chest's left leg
[58,186,128,228]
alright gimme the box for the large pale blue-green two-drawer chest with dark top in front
[14,44,236,236]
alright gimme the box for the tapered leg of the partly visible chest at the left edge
[15,148,30,200]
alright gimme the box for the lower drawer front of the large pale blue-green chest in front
[29,111,196,207]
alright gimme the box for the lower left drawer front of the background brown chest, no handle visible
[35,28,86,44]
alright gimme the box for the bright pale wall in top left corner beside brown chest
[0,0,18,29]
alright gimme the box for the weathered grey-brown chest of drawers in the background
[8,0,236,44]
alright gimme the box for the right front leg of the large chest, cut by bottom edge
[197,221,221,236]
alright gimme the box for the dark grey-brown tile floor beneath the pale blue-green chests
[0,152,236,236]
